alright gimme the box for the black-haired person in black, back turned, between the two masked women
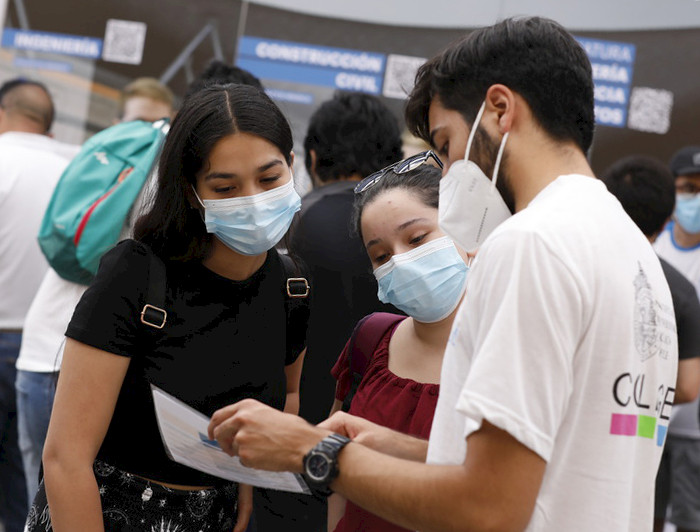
[290,92,402,423]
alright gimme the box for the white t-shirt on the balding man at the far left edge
[0,132,79,329]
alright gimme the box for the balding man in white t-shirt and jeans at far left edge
[0,78,78,532]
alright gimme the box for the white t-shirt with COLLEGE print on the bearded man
[428,175,678,532]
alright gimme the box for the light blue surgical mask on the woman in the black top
[195,179,301,256]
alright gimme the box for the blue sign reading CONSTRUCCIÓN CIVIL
[236,37,386,94]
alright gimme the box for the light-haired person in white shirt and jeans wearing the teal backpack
[16,78,174,508]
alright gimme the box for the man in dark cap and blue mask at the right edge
[654,146,700,532]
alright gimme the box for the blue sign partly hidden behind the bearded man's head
[577,37,636,127]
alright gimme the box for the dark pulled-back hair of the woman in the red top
[352,164,442,238]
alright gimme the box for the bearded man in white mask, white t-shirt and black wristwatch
[202,17,678,532]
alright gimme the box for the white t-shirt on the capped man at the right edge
[654,222,700,440]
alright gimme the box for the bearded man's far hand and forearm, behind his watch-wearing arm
[318,412,428,462]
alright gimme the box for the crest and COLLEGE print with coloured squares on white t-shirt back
[610,263,676,446]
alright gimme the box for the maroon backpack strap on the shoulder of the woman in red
[343,312,406,412]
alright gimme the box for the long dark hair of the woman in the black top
[134,84,293,262]
